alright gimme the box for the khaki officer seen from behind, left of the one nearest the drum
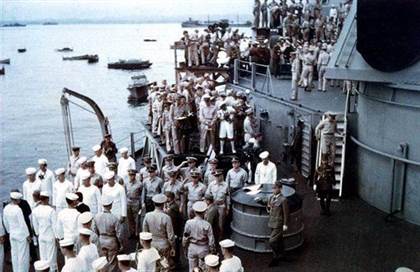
[143,194,175,266]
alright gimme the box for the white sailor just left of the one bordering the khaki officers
[78,170,102,215]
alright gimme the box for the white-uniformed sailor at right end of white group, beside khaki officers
[102,171,127,222]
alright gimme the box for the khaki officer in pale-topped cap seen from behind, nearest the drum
[182,201,215,272]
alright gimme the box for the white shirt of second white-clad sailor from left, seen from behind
[32,205,57,241]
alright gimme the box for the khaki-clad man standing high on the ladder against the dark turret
[315,112,337,166]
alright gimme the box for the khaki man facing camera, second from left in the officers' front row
[141,165,163,212]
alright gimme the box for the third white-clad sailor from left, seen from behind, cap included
[56,193,80,241]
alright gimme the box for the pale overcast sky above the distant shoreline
[0,0,254,21]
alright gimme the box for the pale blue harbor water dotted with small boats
[0,24,249,200]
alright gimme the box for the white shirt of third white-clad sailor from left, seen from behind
[56,208,80,241]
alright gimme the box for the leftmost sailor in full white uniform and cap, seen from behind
[3,192,31,272]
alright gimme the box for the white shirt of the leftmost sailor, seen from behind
[3,203,29,241]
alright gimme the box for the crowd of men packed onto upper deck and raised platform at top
[181,0,355,100]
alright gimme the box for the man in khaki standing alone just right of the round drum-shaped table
[267,180,289,267]
